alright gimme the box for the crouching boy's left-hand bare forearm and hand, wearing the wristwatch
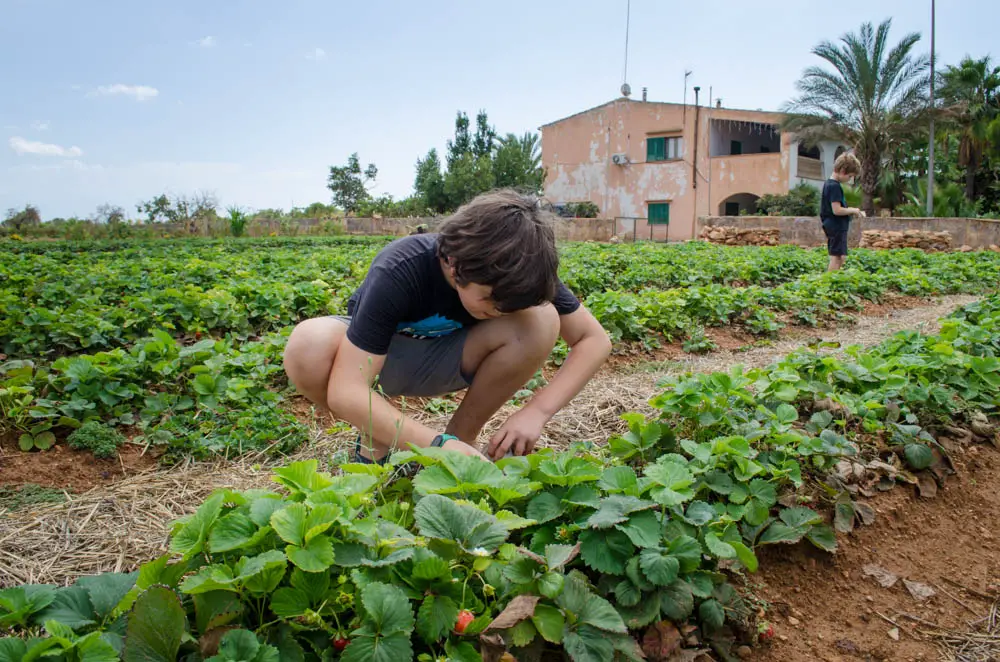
[326,336,480,455]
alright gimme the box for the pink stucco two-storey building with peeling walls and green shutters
[541,98,844,240]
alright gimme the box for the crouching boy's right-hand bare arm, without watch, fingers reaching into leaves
[486,305,611,459]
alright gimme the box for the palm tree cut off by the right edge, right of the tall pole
[941,55,1000,201]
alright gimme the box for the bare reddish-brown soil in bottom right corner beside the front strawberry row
[751,446,1000,662]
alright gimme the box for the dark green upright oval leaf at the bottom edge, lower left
[122,586,187,662]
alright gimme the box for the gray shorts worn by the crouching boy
[333,315,472,397]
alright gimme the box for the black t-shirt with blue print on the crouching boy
[347,234,580,356]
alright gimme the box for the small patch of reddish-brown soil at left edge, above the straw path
[0,439,156,492]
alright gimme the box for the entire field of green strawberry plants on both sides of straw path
[0,237,1000,662]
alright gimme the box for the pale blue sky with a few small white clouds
[0,0,1000,218]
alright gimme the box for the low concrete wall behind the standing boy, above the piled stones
[698,216,1000,249]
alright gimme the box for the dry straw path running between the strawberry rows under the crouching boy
[0,296,974,592]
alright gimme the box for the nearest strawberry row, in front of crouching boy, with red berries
[0,296,1000,662]
